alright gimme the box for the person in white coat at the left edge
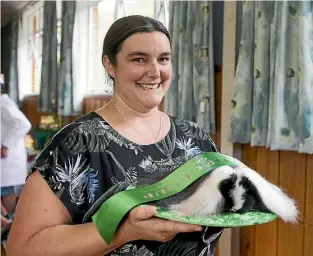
[0,77,31,224]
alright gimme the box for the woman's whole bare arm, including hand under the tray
[7,171,202,256]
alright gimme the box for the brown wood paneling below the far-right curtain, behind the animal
[240,145,313,256]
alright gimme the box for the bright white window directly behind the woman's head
[87,0,168,95]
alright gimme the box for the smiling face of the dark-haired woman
[106,32,172,111]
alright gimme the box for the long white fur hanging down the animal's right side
[235,167,299,223]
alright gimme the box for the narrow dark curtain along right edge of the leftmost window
[38,1,58,113]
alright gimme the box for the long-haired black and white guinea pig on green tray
[154,166,299,223]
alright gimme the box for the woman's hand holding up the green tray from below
[116,206,202,244]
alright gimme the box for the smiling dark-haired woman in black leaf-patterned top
[7,16,222,256]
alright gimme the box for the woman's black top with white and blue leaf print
[30,112,222,256]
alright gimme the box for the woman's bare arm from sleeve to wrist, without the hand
[7,171,123,256]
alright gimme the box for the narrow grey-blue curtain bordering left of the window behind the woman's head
[58,1,75,116]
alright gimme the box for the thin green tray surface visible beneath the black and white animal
[155,207,277,228]
